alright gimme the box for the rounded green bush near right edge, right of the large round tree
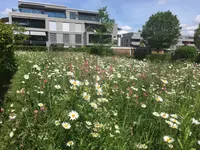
[173,46,197,61]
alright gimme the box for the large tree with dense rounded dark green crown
[141,11,181,51]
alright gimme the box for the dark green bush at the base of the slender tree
[90,45,114,56]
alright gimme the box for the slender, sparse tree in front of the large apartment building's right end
[91,7,115,55]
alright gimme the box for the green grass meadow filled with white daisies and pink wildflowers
[0,52,200,150]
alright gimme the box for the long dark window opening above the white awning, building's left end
[12,18,45,28]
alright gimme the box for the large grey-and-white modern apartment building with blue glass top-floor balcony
[4,1,118,47]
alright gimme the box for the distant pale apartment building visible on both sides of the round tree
[118,32,195,50]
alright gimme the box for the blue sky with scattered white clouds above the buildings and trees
[0,0,200,35]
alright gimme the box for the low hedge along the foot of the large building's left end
[15,45,48,51]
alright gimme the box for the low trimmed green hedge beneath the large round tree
[146,54,171,62]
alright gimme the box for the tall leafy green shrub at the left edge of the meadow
[0,22,26,104]
